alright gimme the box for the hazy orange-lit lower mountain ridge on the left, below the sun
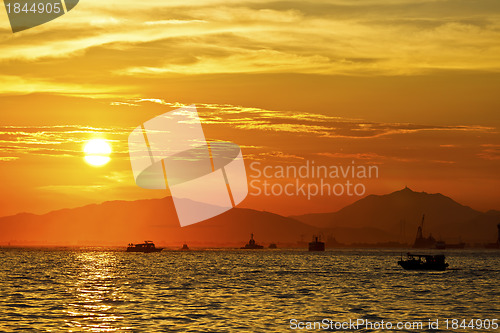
[0,197,393,247]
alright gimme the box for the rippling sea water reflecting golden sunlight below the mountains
[0,248,500,332]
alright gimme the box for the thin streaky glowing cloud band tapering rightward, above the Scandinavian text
[126,99,495,139]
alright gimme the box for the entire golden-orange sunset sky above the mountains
[0,0,500,216]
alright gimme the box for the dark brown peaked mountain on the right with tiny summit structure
[292,187,500,242]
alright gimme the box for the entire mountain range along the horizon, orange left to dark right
[0,188,500,247]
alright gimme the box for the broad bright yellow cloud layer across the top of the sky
[0,0,500,93]
